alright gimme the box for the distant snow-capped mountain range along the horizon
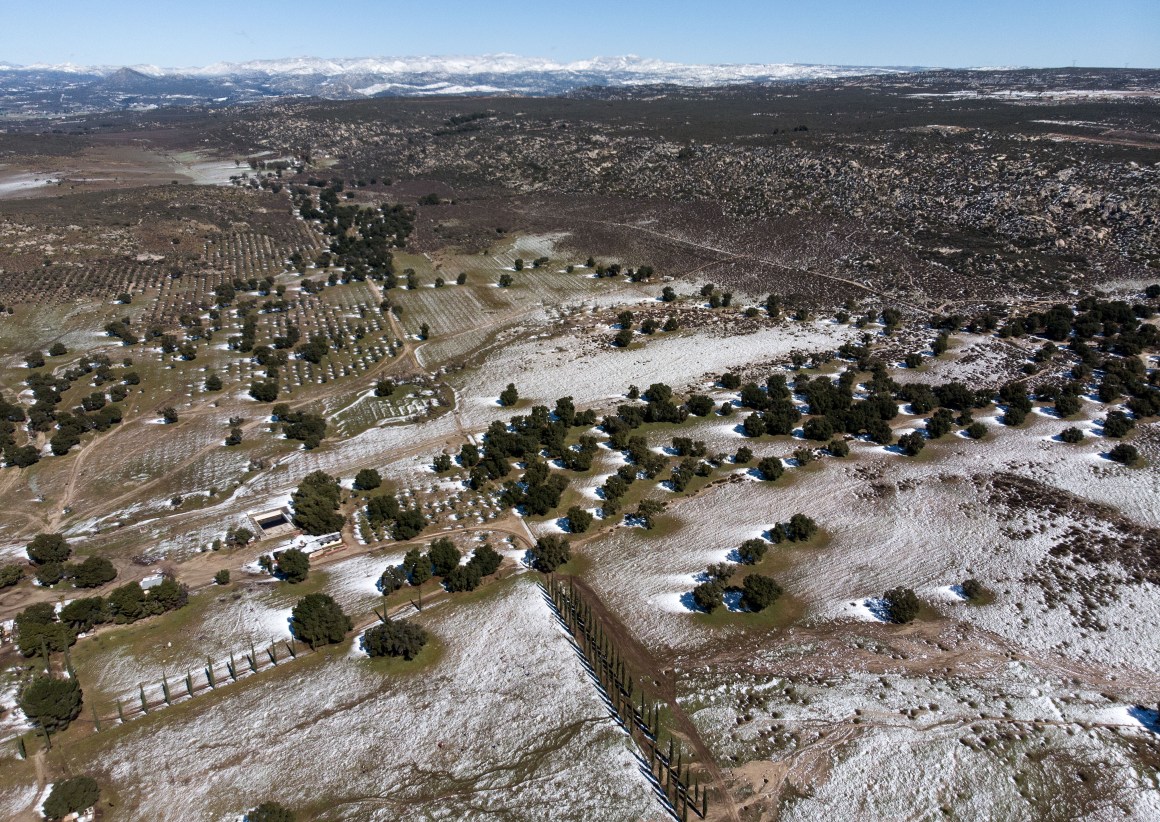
[0,54,920,114]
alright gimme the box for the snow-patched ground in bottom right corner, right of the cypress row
[686,658,1160,820]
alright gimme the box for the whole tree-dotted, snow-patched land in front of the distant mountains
[0,73,1160,820]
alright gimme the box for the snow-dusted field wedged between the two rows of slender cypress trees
[84,577,665,820]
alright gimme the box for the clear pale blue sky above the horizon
[0,0,1160,67]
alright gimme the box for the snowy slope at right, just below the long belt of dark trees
[585,405,1160,672]
